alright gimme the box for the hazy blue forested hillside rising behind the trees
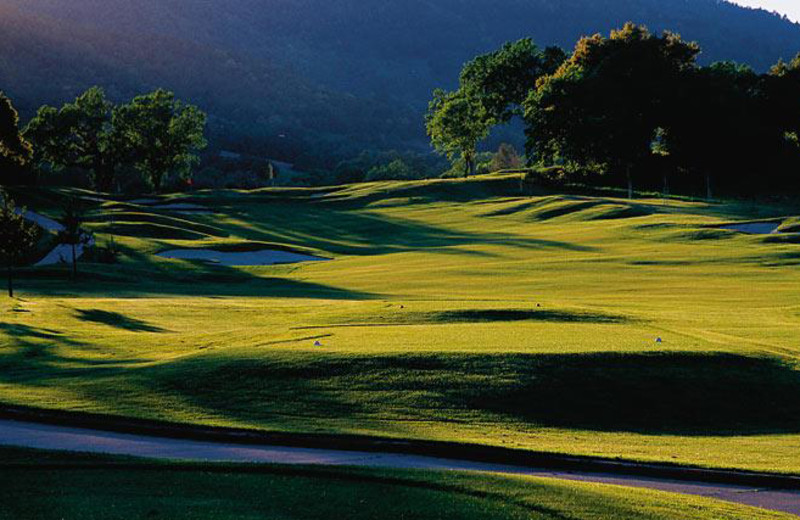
[0,0,800,162]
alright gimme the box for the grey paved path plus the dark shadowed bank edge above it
[0,407,800,516]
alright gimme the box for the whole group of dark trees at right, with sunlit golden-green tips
[427,23,800,198]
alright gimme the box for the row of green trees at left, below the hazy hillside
[0,87,206,192]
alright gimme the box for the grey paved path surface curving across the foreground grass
[0,420,800,516]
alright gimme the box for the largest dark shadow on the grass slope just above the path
[148,353,800,436]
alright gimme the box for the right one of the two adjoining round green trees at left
[112,90,207,191]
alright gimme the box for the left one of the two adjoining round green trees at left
[25,87,125,192]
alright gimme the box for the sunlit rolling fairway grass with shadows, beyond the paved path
[0,176,800,473]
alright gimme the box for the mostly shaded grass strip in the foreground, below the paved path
[0,448,793,520]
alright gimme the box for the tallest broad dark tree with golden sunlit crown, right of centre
[525,23,699,198]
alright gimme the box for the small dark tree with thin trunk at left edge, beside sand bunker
[0,191,41,298]
